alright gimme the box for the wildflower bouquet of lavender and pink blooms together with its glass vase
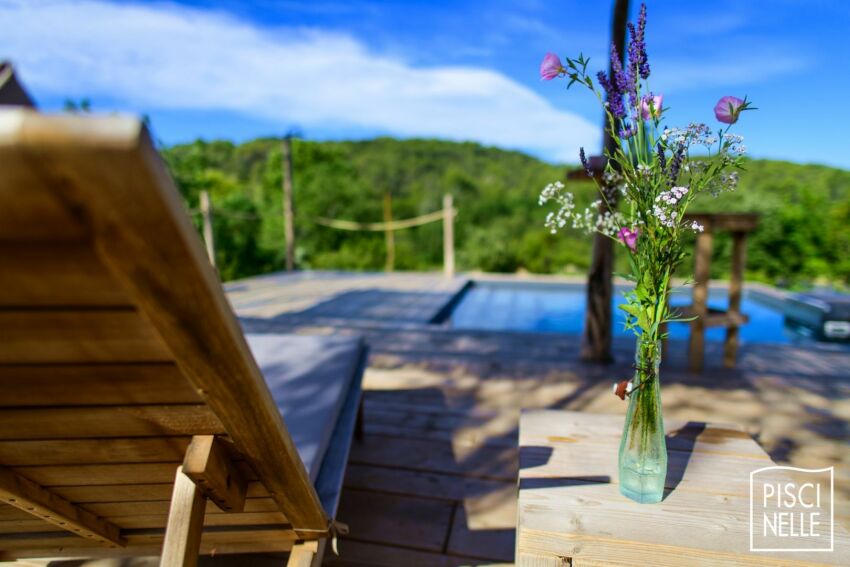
[540,5,751,502]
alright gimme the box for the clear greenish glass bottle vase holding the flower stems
[619,337,667,504]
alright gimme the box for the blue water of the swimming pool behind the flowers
[448,281,806,343]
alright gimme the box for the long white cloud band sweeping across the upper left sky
[0,0,599,161]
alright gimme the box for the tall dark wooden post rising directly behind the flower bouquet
[581,0,629,362]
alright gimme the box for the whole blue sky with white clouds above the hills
[0,0,850,168]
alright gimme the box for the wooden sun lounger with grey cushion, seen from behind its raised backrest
[0,109,365,566]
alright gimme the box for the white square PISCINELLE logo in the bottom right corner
[750,465,835,552]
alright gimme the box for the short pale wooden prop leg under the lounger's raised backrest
[160,467,207,567]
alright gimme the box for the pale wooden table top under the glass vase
[516,410,850,567]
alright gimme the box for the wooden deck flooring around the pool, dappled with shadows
[228,273,850,566]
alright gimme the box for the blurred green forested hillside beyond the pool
[163,138,850,286]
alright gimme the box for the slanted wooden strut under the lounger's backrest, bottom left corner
[0,467,126,548]
